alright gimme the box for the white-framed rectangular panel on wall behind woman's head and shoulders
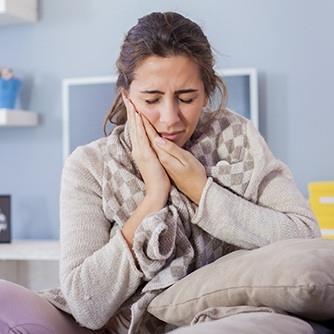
[62,67,259,161]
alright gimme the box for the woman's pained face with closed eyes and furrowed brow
[124,56,208,147]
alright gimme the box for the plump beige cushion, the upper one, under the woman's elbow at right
[148,239,334,326]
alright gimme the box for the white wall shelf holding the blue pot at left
[0,109,38,127]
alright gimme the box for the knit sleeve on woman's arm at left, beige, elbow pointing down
[60,144,142,329]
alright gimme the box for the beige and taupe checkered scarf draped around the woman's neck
[100,109,254,333]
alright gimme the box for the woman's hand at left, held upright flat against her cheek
[126,99,170,206]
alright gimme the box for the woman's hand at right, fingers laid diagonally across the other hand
[143,117,207,204]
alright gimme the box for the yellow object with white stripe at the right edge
[308,181,334,238]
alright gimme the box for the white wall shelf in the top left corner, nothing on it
[0,0,37,25]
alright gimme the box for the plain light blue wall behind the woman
[0,0,334,238]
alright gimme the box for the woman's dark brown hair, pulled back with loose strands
[104,12,227,135]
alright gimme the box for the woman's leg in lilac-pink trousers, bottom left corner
[0,279,93,334]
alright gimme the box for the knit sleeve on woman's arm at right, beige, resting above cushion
[193,122,320,249]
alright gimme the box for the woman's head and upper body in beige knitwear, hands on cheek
[0,12,320,333]
